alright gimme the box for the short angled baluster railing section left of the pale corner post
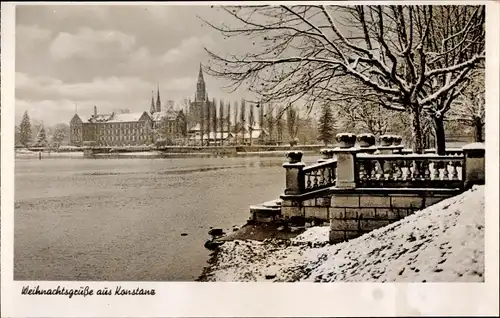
[302,159,337,192]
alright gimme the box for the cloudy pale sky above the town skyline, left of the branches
[16,5,254,125]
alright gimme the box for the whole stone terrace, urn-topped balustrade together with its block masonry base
[266,134,485,243]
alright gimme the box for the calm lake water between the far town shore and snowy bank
[14,158,316,281]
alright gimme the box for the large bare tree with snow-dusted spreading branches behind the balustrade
[200,5,485,153]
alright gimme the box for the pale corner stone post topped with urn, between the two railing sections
[334,133,358,189]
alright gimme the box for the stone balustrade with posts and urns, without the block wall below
[283,133,484,195]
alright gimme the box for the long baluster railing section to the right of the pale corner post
[355,153,465,188]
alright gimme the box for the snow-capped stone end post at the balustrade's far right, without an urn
[462,142,485,189]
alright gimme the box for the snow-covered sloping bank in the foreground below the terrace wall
[200,186,484,282]
